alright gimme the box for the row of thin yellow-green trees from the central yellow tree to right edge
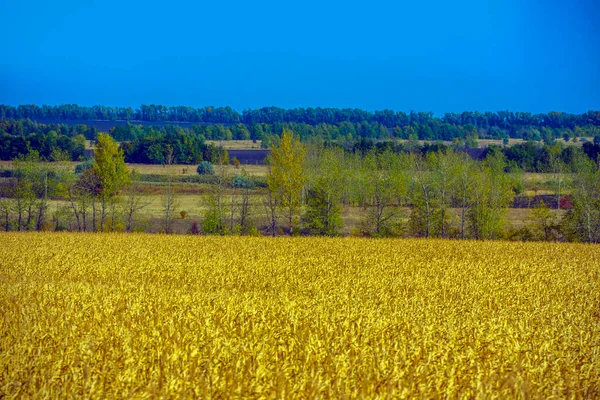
[195,131,600,243]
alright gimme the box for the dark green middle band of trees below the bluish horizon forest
[0,120,600,172]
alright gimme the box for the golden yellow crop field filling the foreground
[0,233,600,398]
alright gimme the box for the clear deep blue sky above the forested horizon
[0,0,600,114]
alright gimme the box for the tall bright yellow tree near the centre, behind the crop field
[267,130,306,234]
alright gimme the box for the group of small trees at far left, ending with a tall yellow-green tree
[0,134,130,231]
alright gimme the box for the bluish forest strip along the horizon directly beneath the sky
[0,104,600,140]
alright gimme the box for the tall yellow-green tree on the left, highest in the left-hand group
[94,133,129,231]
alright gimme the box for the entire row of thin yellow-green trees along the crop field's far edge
[0,131,600,243]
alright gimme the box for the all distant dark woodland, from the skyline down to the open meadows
[0,105,600,172]
